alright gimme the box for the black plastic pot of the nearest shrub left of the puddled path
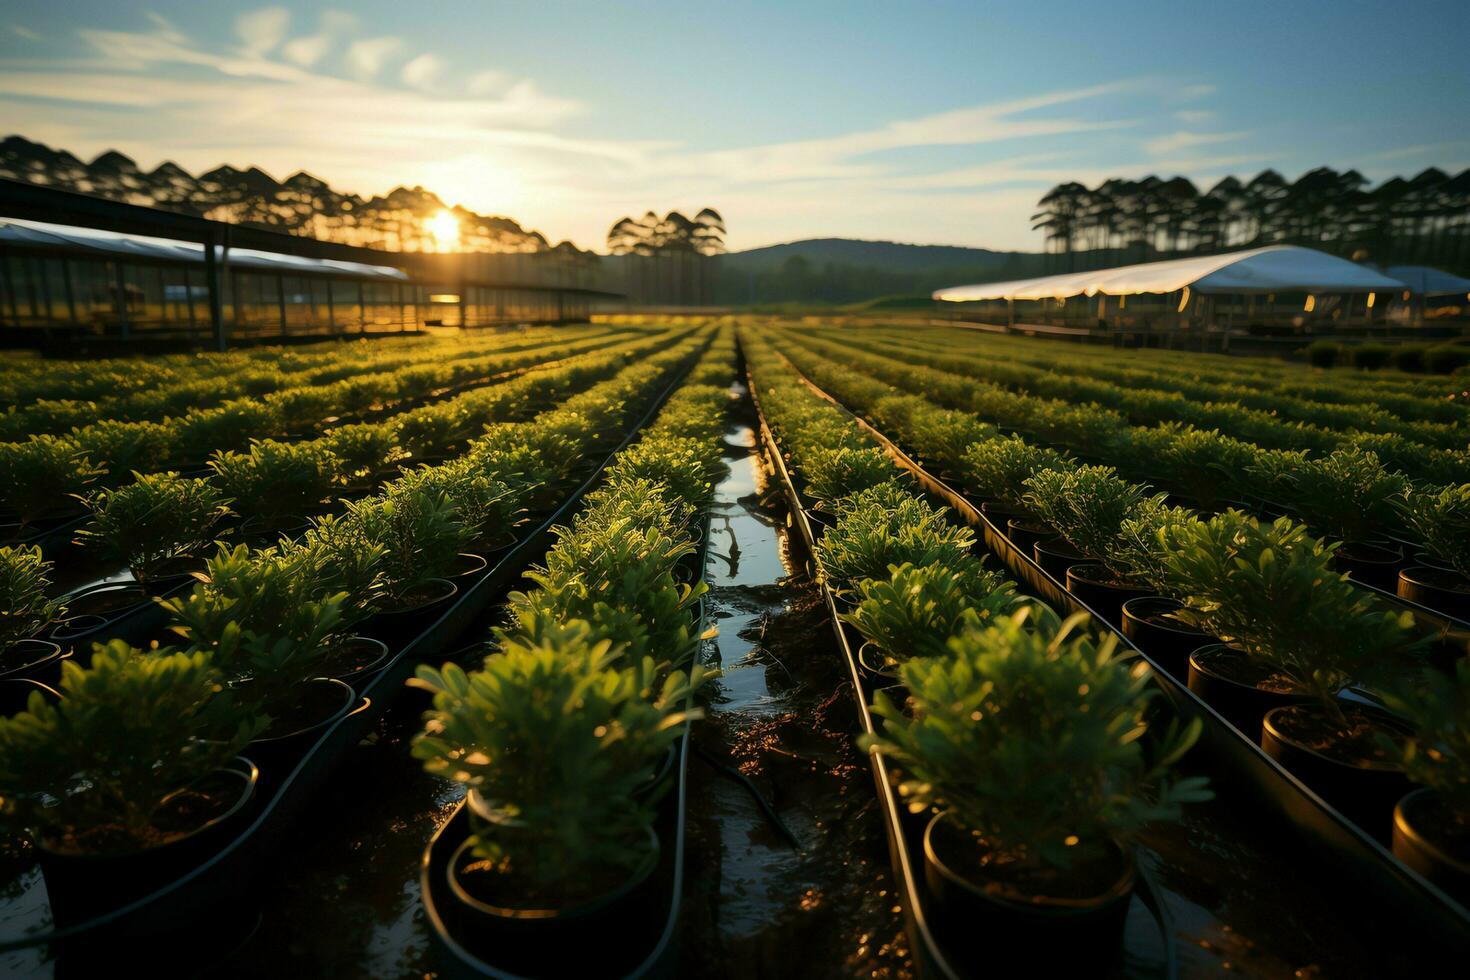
[445,829,659,977]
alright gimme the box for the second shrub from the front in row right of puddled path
[842,557,1016,679]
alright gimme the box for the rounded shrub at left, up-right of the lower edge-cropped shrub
[76,473,229,594]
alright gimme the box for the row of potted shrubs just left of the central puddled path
[410,332,734,976]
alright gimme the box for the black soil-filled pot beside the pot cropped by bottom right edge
[1261,704,1411,840]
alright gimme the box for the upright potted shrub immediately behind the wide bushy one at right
[1025,466,1163,623]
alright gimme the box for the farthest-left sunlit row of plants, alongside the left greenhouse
[0,321,612,441]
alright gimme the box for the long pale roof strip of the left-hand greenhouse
[0,217,409,282]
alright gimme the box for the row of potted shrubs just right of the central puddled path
[745,339,1210,971]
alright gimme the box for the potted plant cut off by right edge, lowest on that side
[1382,660,1470,902]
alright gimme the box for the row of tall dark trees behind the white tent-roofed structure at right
[1032,167,1470,270]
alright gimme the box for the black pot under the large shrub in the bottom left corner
[37,760,257,924]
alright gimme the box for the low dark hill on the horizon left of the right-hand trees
[719,238,1047,306]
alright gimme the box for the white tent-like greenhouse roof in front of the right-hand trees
[933,245,1407,303]
